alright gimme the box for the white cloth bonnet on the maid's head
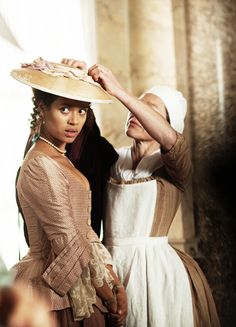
[142,85,187,133]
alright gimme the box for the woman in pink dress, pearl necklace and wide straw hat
[11,58,126,327]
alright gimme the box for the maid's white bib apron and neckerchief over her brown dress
[104,147,194,327]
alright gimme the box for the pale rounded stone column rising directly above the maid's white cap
[129,0,176,95]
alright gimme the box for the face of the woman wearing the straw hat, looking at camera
[41,97,89,146]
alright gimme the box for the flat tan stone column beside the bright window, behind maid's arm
[95,0,131,147]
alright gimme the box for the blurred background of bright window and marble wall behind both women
[0,0,236,327]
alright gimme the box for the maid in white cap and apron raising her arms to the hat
[80,64,220,327]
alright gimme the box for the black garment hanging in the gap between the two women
[66,122,118,236]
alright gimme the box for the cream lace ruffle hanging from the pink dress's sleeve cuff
[69,243,114,320]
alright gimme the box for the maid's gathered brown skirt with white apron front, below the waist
[106,237,220,327]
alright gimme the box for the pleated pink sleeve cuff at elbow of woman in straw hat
[42,234,91,296]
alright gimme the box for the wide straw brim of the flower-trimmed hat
[11,68,112,103]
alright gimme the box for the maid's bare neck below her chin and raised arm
[131,140,160,170]
